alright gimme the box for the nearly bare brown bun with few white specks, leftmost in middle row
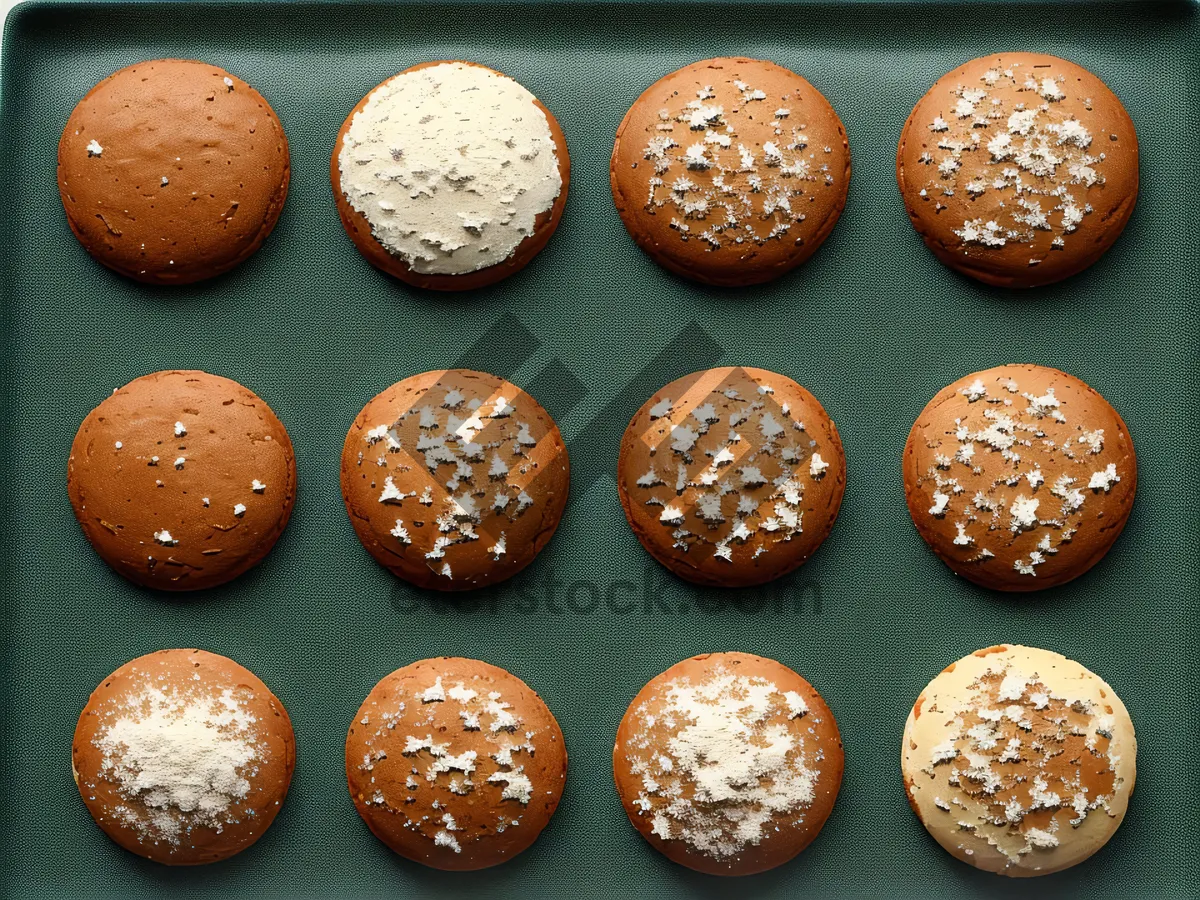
[67,371,296,590]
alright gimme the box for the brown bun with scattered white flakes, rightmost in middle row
[904,365,1138,590]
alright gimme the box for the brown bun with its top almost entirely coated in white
[330,61,571,290]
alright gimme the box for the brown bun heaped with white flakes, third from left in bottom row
[612,653,845,875]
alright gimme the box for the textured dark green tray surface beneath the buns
[0,2,1200,898]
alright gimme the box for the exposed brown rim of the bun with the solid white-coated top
[329,60,571,290]
